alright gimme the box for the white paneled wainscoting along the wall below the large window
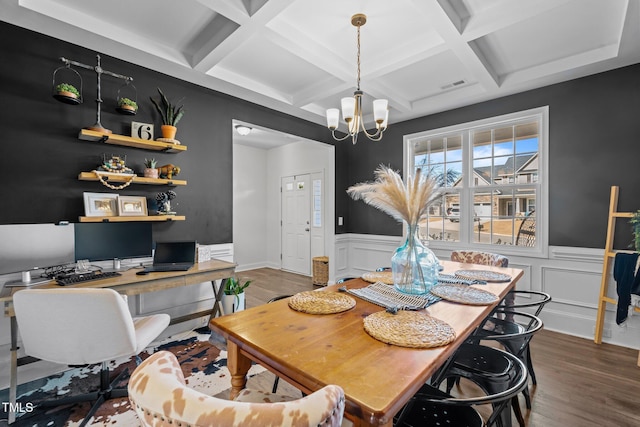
[336,234,640,349]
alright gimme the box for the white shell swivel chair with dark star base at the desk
[13,288,170,426]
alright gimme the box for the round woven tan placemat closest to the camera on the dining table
[364,310,456,348]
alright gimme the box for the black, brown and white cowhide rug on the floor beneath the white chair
[0,333,270,427]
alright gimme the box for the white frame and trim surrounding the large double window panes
[402,106,549,258]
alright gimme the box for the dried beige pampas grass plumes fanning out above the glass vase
[347,165,440,226]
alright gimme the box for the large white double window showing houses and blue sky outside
[404,107,548,253]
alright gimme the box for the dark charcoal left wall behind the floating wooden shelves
[0,23,331,244]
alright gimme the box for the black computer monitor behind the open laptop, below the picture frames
[75,222,153,261]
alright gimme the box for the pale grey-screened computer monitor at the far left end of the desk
[0,224,75,280]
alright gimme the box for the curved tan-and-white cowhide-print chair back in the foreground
[129,351,345,427]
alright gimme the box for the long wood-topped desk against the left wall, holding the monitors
[0,259,236,423]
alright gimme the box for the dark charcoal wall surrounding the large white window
[336,64,640,248]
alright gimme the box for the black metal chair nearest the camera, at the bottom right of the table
[393,344,527,427]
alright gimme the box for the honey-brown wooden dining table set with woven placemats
[209,261,523,426]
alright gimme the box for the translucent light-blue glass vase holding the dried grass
[391,224,440,295]
